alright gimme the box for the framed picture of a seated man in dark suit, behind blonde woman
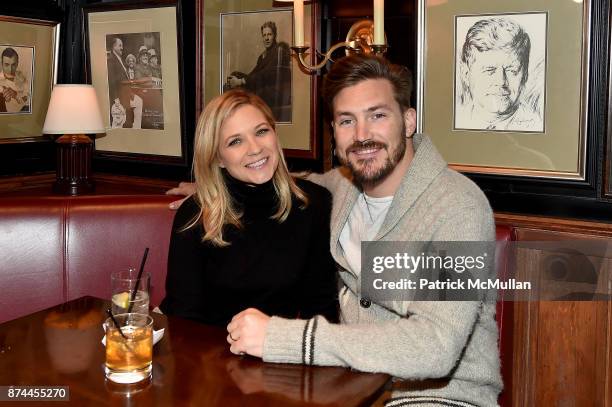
[198,0,318,158]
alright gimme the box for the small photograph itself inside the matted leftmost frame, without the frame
[0,44,34,115]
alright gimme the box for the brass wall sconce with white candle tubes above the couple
[277,0,387,72]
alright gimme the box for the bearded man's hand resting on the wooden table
[227,308,270,358]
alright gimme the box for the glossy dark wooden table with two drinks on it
[0,297,389,407]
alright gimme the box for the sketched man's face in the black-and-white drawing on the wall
[467,50,525,115]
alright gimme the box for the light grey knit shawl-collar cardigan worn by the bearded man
[263,134,502,406]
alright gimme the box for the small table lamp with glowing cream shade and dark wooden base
[43,85,105,195]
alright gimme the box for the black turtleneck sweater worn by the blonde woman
[160,174,338,326]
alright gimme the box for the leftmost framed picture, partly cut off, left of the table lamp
[0,16,60,143]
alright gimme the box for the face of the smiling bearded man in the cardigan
[333,79,416,184]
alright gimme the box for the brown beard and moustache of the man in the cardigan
[341,124,406,186]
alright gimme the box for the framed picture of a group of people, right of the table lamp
[83,0,187,165]
